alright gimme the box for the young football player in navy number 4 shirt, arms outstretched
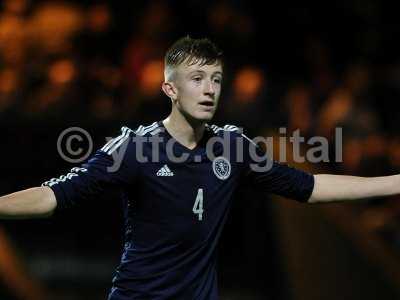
[0,37,400,300]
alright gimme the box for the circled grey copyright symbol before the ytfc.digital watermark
[57,127,93,164]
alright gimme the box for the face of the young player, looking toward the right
[168,62,222,122]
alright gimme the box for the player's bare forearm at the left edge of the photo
[0,186,57,219]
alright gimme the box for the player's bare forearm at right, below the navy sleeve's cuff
[308,174,400,203]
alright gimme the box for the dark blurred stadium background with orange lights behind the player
[0,0,400,300]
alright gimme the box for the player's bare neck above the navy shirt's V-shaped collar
[163,109,206,149]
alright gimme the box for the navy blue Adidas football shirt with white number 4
[43,122,314,300]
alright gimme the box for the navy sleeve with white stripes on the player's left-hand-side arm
[42,127,137,209]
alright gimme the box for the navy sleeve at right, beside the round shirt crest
[242,135,314,202]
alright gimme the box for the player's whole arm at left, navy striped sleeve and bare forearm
[0,127,137,219]
